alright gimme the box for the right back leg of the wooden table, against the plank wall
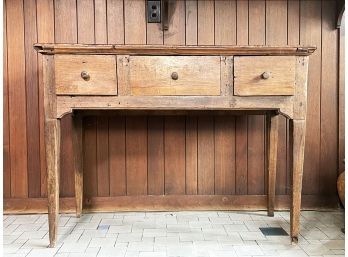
[267,114,279,217]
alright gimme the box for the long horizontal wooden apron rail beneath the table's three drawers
[57,96,293,118]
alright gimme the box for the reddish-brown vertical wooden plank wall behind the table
[4,0,338,210]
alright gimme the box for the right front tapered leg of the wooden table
[290,120,306,243]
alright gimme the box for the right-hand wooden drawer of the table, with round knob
[234,56,296,96]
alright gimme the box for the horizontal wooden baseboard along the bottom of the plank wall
[4,195,340,214]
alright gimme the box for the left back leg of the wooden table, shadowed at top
[73,114,83,217]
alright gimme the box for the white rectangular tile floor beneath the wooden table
[3,211,345,257]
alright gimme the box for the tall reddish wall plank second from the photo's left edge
[6,0,28,198]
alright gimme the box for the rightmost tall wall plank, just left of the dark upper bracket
[320,1,338,195]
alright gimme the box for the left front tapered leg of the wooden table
[45,119,60,247]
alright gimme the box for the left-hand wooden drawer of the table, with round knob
[54,55,117,95]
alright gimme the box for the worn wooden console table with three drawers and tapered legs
[34,44,315,247]
